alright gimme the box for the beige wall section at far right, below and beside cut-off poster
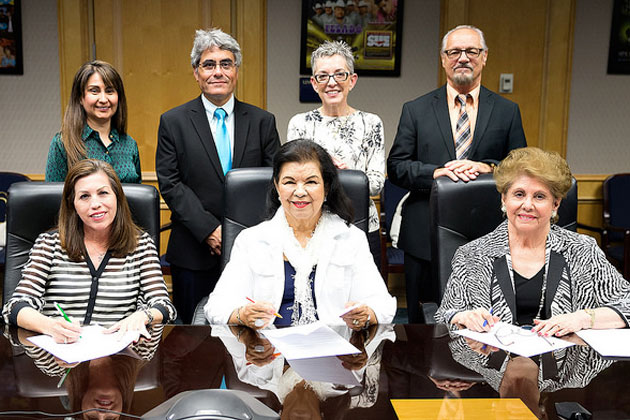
[567,0,630,174]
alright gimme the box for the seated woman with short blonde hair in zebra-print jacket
[436,147,630,336]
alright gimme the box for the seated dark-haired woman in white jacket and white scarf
[204,140,396,330]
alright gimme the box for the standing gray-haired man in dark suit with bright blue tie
[155,29,280,324]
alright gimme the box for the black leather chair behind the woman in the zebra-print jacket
[423,174,577,322]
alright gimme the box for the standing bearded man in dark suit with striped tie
[387,25,527,323]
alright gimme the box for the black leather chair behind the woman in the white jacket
[192,168,370,325]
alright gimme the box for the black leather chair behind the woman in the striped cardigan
[2,182,160,305]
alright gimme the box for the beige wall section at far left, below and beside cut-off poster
[0,0,61,173]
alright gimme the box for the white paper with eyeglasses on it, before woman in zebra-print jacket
[455,322,573,357]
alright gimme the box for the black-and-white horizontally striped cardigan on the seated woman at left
[2,231,176,327]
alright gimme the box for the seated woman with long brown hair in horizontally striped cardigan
[3,160,176,343]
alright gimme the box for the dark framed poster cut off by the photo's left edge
[0,0,24,74]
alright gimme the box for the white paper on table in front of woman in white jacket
[261,322,360,360]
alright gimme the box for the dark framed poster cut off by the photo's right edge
[608,0,630,74]
